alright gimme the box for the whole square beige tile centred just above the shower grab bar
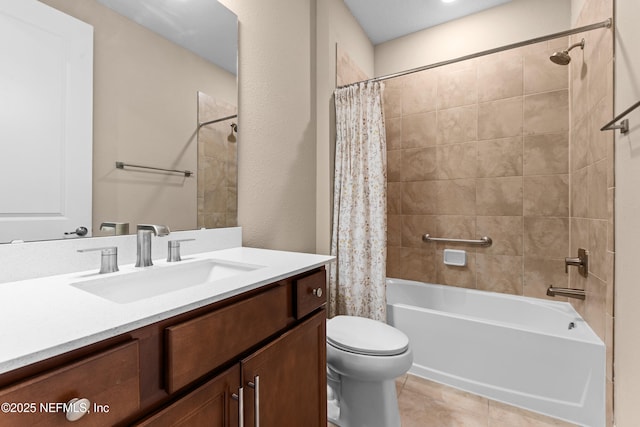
[435,179,476,215]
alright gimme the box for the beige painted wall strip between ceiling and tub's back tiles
[375,0,571,76]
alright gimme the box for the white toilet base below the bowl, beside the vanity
[327,376,400,427]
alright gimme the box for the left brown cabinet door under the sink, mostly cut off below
[136,364,240,427]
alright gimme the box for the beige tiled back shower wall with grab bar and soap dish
[384,38,570,297]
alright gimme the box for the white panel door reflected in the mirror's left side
[0,0,93,243]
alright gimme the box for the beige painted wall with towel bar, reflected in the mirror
[42,0,237,235]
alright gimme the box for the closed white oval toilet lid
[327,316,409,356]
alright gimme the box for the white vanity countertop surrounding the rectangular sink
[0,247,333,374]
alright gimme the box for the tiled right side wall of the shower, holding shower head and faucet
[569,0,615,426]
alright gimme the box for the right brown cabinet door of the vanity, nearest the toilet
[241,310,327,427]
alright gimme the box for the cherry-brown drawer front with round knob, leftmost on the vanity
[0,341,140,426]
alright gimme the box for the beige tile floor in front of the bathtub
[329,375,574,427]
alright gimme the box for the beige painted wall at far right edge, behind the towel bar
[614,0,640,427]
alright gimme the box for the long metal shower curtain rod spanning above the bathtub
[338,18,613,89]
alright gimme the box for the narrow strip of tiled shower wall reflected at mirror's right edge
[196,92,238,228]
